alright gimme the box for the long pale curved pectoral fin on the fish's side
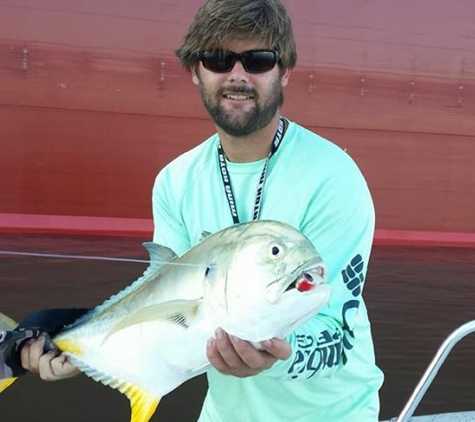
[104,300,201,342]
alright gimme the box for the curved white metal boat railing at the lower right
[391,320,475,422]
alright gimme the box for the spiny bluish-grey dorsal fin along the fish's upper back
[71,242,177,326]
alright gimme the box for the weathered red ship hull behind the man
[0,0,475,245]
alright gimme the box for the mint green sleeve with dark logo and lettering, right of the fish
[265,160,375,380]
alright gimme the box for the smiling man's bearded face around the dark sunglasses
[192,41,289,137]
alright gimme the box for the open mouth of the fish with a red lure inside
[264,257,326,303]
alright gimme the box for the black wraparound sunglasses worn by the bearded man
[198,50,279,73]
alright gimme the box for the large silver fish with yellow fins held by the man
[0,220,331,422]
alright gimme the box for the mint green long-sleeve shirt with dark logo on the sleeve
[152,122,383,422]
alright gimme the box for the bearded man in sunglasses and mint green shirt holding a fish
[22,0,383,422]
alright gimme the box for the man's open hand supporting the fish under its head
[206,328,292,378]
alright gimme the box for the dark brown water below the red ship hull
[0,234,475,422]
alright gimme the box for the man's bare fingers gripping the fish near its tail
[21,336,79,381]
